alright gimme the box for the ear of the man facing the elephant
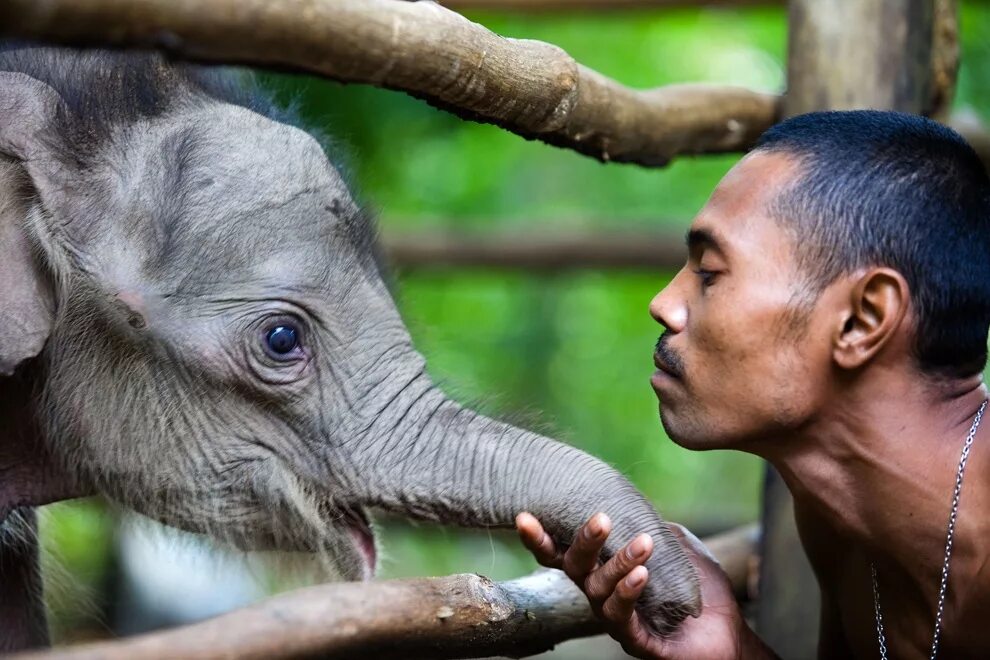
[832,268,911,369]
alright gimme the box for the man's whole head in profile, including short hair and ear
[650,111,990,448]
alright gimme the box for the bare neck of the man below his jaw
[765,378,990,554]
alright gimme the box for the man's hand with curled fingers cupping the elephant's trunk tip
[516,513,774,660]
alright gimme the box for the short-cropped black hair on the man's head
[756,110,990,378]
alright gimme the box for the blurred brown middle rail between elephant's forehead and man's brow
[381,231,687,271]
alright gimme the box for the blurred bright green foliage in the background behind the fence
[38,1,990,636]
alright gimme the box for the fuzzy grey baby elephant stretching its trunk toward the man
[0,46,699,647]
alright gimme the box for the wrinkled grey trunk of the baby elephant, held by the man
[349,372,701,633]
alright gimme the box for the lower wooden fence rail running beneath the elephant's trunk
[12,525,758,660]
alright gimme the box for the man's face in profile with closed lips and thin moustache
[650,152,830,453]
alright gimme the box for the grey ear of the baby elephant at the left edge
[0,72,61,376]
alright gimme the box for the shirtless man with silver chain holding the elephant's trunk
[517,111,990,658]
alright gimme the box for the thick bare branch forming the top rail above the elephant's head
[0,0,779,166]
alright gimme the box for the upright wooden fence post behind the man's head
[756,0,955,658]
